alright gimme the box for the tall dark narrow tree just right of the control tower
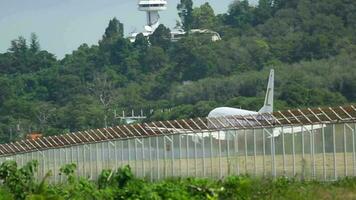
[177,0,193,32]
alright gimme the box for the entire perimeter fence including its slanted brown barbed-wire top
[0,106,356,182]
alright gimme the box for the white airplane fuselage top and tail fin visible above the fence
[208,69,274,117]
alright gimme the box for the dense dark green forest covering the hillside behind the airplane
[0,0,356,142]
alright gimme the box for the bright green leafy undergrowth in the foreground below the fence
[0,161,356,200]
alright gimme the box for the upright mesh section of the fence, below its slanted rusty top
[0,123,356,182]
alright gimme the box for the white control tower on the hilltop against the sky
[138,0,167,33]
